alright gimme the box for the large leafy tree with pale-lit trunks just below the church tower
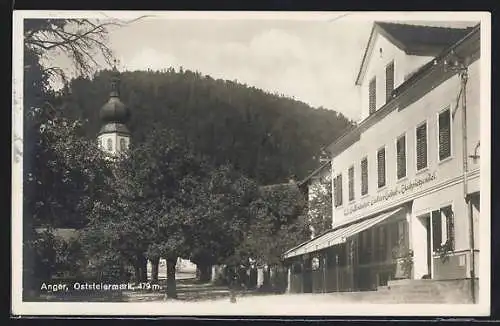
[81,128,206,297]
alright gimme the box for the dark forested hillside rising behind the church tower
[61,68,351,184]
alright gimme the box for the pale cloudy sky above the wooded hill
[40,13,484,120]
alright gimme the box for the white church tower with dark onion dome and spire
[97,65,130,157]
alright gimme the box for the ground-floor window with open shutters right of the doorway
[431,205,455,252]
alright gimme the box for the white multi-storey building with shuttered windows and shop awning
[284,23,481,298]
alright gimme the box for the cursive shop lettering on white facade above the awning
[344,172,436,216]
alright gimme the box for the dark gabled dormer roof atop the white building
[356,22,473,85]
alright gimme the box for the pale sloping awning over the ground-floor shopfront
[283,207,404,259]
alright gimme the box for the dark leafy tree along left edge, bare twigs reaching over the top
[22,19,119,294]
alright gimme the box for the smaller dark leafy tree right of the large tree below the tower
[188,165,258,281]
